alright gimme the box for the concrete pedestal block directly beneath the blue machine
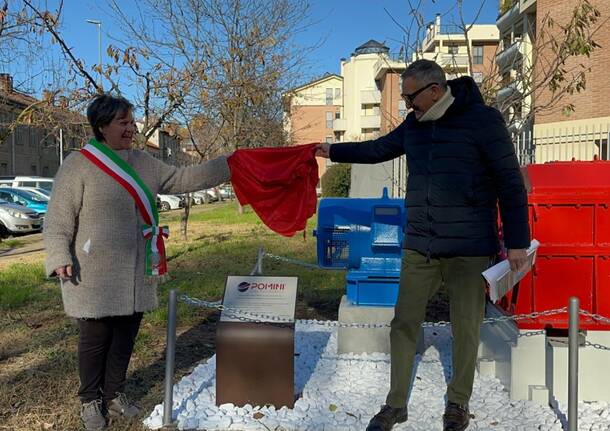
[337,295,424,353]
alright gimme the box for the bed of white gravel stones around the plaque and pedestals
[144,323,610,431]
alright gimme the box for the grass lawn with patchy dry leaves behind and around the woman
[0,202,344,430]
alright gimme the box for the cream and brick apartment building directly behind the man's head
[413,14,500,83]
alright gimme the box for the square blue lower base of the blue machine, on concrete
[346,271,400,307]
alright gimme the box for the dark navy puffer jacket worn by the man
[330,77,529,257]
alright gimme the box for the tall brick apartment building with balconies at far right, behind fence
[496,0,610,164]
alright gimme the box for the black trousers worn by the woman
[78,313,142,403]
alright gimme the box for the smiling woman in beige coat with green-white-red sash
[44,95,230,430]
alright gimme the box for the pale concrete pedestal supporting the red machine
[479,304,610,405]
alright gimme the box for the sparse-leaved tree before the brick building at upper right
[446,0,608,133]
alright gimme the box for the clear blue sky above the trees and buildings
[7,0,498,97]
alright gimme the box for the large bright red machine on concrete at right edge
[498,161,610,330]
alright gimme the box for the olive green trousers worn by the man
[386,250,490,407]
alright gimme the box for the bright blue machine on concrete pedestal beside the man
[314,188,406,306]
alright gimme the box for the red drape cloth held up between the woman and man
[228,144,318,236]
